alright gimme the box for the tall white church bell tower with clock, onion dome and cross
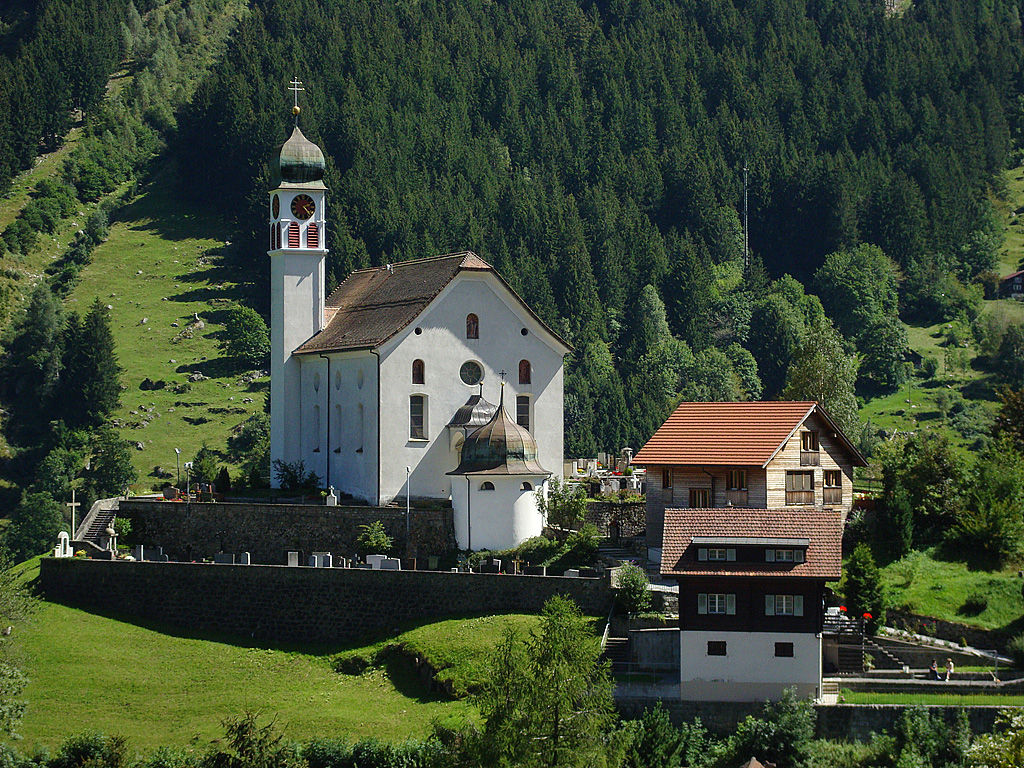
[268,80,327,475]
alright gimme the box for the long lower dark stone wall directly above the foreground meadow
[40,558,611,643]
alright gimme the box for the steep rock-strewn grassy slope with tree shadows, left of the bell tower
[68,167,268,492]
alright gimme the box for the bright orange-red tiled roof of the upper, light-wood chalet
[633,400,866,467]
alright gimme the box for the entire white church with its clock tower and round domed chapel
[268,112,569,549]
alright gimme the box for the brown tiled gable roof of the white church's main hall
[295,251,567,354]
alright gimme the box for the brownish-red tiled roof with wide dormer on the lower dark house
[662,507,843,581]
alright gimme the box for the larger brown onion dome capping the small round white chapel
[449,392,551,475]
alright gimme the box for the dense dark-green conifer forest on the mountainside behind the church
[176,0,1022,455]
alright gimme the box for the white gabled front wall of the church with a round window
[380,272,563,507]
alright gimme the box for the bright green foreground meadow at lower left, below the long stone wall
[15,566,499,751]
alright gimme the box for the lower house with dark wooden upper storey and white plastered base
[662,507,843,701]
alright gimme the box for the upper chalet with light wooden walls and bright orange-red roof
[633,400,866,561]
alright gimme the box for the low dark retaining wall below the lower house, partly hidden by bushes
[615,698,1001,741]
